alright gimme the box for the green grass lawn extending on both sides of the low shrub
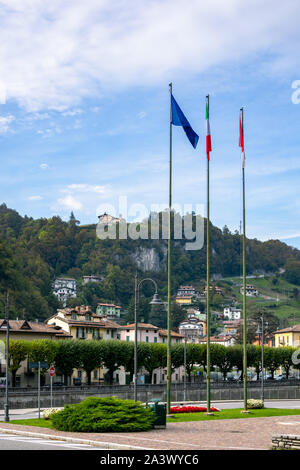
[5,408,300,429]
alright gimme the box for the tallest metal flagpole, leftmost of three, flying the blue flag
[167,83,172,414]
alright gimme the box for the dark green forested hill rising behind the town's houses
[0,204,300,319]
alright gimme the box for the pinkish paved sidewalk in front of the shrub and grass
[0,415,300,450]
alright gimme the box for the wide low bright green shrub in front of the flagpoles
[51,397,155,432]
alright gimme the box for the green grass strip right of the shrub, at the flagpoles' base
[167,408,300,423]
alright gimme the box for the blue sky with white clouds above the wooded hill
[0,0,300,248]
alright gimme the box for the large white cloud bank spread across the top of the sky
[0,0,299,112]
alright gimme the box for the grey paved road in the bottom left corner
[0,433,100,451]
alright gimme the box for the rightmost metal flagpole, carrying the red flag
[241,108,247,411]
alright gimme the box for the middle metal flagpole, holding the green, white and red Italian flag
[206,95,210,413]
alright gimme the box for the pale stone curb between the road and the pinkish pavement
[0,427,153,450]
